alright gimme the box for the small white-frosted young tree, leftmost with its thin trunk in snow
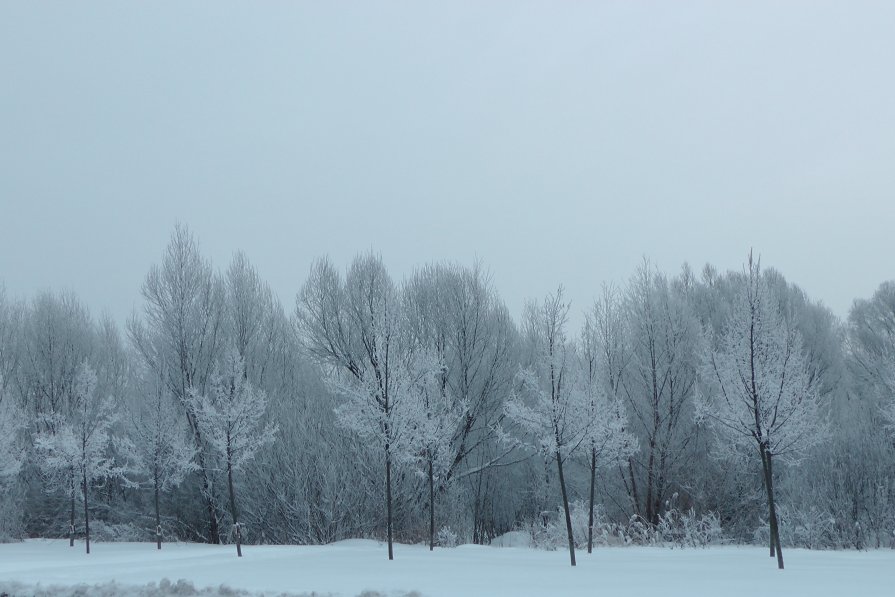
[35,363,123,554]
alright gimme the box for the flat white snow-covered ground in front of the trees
[0,540,895,597]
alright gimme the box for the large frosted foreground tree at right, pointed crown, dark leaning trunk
[696,254,825,569]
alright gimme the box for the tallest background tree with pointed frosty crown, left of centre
[128,226,224,543]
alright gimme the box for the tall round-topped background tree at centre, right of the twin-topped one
[403,263,518,543]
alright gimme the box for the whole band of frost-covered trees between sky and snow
[0,227,895,566]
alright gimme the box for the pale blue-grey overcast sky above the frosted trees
[0,0,895,320]
